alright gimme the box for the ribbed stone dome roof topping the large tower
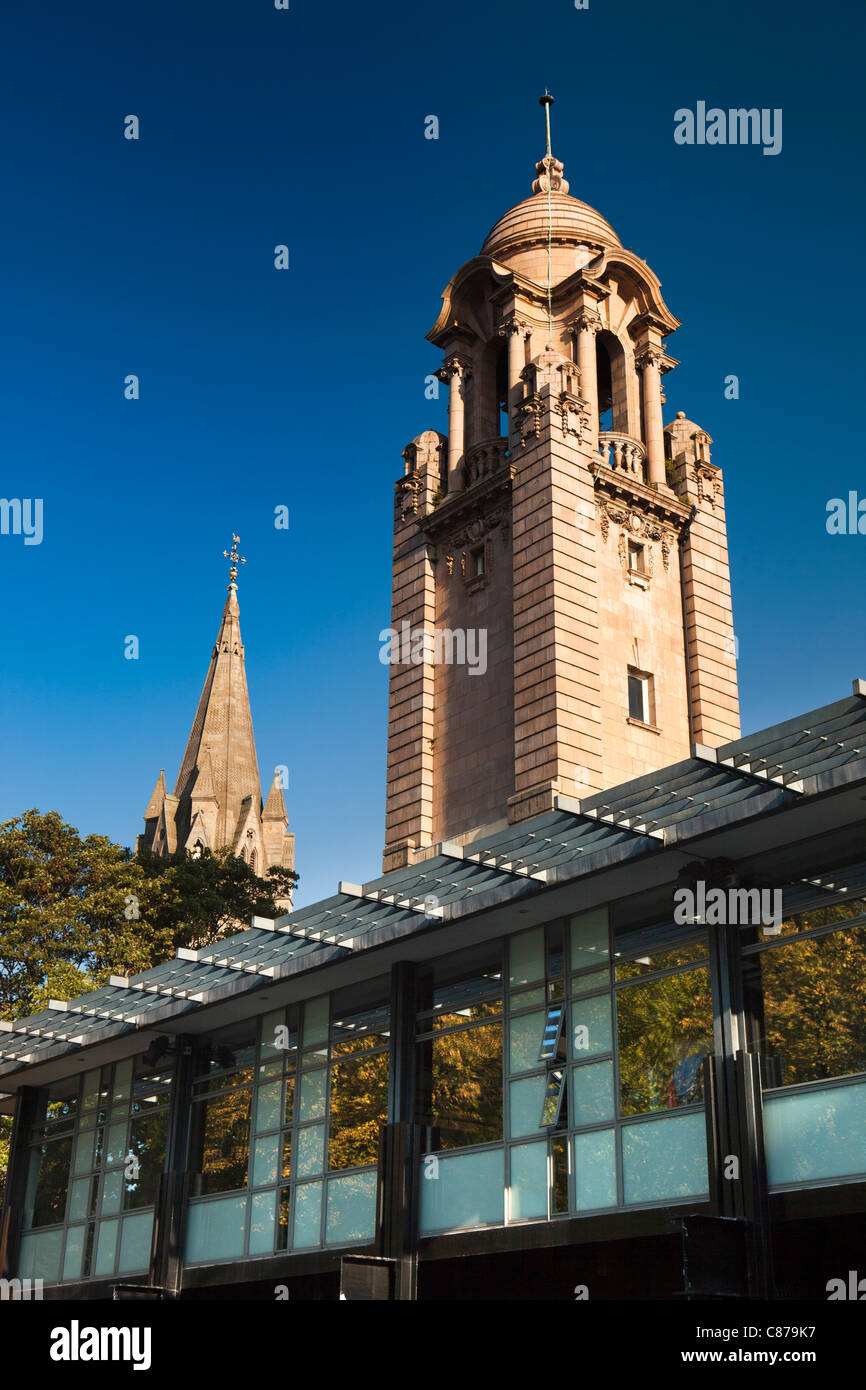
[481,158,623,281]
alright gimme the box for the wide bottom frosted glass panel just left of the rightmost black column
[623,1112,708,1202]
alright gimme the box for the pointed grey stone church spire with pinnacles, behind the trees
[136,538,295,876]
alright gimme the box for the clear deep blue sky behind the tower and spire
[0,0,866,904]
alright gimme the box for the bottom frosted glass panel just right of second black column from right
[421,1148,505,1230]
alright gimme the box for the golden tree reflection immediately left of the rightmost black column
[617,969,713,1115]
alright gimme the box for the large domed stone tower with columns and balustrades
[384,99,740,870]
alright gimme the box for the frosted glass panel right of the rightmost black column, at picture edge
[763,1083,866,1186]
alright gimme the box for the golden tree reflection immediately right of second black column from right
[421,1023,502,1148]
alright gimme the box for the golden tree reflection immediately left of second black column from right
[328,1034,388,1169]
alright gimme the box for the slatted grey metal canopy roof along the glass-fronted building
[0,682,866,1077]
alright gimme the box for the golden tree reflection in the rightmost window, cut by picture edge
[752,922,866,1086]
